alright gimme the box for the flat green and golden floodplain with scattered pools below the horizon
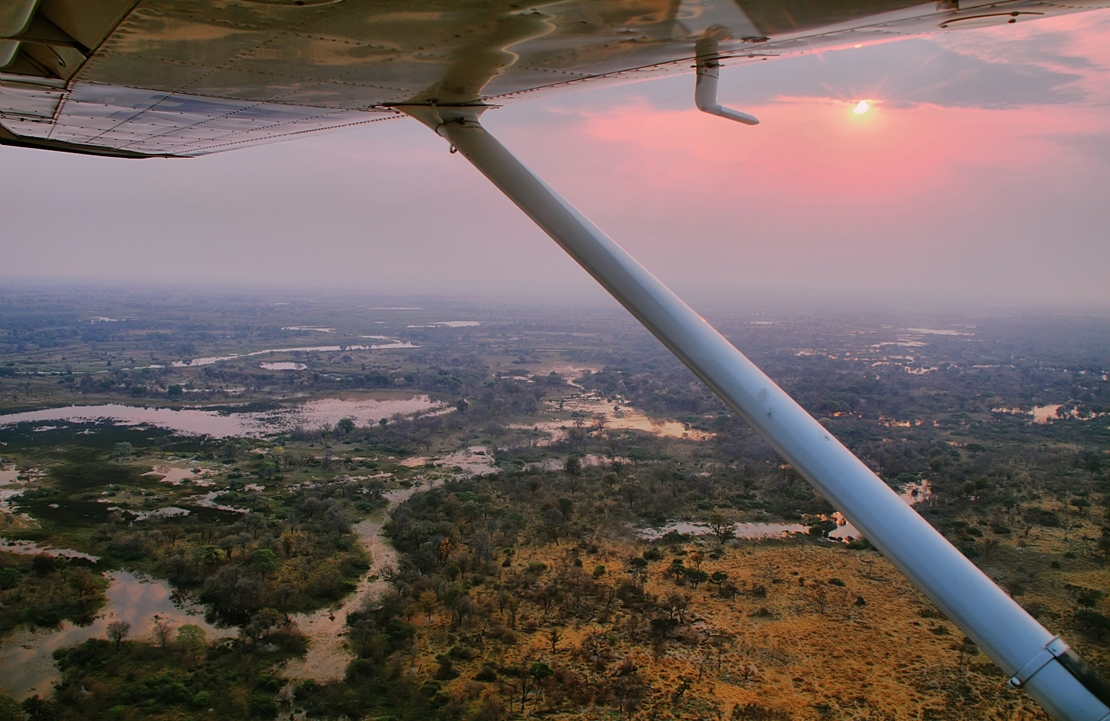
[0,288,1110,720]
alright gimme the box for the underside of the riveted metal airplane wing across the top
[0,0,1110,158]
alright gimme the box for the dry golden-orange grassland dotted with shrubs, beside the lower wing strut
[397,527,1107,720]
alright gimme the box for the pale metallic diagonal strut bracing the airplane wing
[397,105,1110,721]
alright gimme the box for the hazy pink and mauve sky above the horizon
[0,11,1110,312]
